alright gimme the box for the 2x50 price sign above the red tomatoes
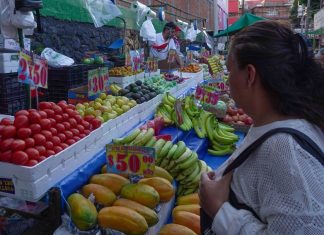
[18,50,48,88]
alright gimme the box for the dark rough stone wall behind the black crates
[32,17,138,62]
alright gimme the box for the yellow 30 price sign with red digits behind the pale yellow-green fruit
[88,68,109,96]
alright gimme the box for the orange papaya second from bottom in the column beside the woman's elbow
[173,211,200,235]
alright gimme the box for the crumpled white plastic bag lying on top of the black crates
[41,48,74,67]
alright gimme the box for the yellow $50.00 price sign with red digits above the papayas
[106,144,155,175]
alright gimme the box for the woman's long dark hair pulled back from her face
[230,21,324,129]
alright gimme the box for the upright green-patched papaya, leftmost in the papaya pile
[67,193,98,231]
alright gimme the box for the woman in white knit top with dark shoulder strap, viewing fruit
[199,21,324,235]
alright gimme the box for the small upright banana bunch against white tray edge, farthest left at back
[155,92,176,125]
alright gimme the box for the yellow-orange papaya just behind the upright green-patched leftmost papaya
[81,184,117,206]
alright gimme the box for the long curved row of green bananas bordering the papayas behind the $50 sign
[113,128,211,196]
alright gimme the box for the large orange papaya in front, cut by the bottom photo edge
[98,206,148,235]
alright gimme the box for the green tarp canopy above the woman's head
[214,13,266,38]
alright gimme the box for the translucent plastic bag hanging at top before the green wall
[84,0,122,28]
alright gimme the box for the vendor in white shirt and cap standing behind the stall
[150,22,182,67]
